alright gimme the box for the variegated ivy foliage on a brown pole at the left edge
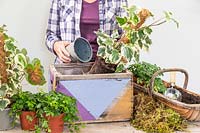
[0,25,46,110]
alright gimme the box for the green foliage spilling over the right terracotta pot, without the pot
[37,91,81,132]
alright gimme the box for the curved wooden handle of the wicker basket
[147,68,188,96]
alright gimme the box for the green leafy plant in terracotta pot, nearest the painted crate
[37,91,80,133]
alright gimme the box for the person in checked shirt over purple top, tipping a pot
[46,0,128,63]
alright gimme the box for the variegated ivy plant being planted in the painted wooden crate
[96,6,178,72]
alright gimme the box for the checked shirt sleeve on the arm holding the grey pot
[46,0,61,54]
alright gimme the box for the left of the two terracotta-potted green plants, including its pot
[11,91,38,130]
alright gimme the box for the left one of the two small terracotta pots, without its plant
[20,111,38,131]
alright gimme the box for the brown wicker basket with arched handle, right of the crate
[133,68,200,121]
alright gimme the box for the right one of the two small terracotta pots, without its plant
[45,113,64,133]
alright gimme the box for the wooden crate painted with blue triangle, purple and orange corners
[50,63,133,123]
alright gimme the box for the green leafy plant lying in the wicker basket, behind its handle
[128,62,166,93]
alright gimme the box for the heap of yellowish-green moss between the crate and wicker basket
[131,94,187,133]
